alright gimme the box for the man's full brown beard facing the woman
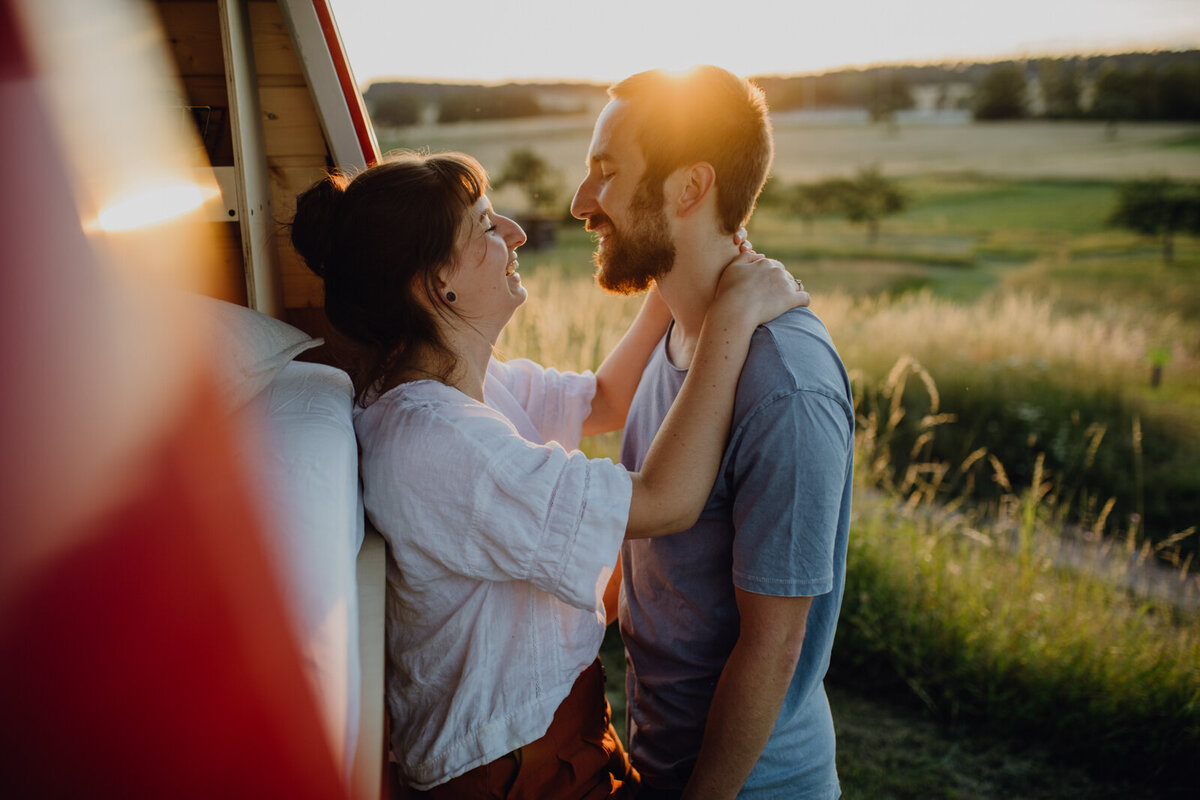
[593,184,676,295]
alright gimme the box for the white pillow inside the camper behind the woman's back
[192,295,324,410]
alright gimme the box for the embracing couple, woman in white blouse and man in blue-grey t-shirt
[292,67,853,800]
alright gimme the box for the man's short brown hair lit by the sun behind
[608,66,775,233]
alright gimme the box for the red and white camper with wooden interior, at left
[0,0,386,799]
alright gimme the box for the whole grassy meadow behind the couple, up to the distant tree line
[385,124,1200,798]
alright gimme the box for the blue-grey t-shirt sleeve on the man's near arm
[731,390,853,597]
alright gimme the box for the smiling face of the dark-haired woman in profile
[442,194,527,336]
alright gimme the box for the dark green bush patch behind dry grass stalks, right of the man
[857,357,1200,558]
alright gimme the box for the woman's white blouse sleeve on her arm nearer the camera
[362,404,632,609]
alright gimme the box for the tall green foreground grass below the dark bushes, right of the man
[830,359,1200,790]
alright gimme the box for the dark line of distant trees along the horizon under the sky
[364,50,1200,127]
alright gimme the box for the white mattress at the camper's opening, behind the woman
[231,361,364,772]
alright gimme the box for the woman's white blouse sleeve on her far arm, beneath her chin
[488,359,596,450]
